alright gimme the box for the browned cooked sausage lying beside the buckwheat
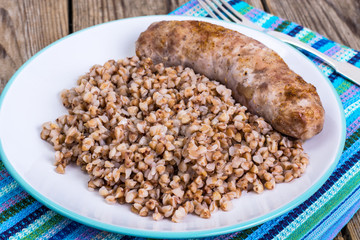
[136,21,324,140]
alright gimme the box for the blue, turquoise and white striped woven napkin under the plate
[0,0,360,239]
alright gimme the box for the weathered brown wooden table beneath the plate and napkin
[0,0,360,239]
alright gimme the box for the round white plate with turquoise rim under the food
[0,16,345,238]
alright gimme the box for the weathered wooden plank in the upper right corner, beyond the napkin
[264,0,360,50]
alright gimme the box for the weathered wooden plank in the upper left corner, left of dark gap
[0,0,68,92]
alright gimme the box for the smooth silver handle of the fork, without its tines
[266,31,360,85]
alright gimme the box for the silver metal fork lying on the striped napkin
[198,0,360,85]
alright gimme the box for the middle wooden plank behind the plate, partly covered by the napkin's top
[72,0,262,31]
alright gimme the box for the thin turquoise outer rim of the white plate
[0,15,346,238]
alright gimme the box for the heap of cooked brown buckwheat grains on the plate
[41,57,308,222]
